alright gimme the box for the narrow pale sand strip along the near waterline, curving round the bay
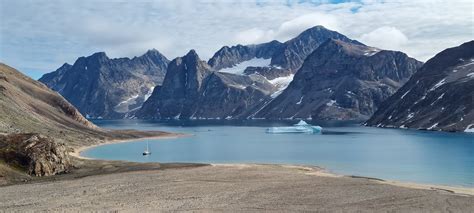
[69,133,474,196]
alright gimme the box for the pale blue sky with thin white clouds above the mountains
[0,0,474,79]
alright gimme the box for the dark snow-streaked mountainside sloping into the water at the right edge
[366,41,474,131]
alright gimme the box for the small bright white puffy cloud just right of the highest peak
[360,26,408,50]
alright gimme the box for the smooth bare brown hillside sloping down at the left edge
[0,64,100,143]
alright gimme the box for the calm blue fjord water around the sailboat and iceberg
[82,120,474,187]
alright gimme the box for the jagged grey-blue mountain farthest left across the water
[39,49,169,118]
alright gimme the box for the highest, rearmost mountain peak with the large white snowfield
[208,26,363,80]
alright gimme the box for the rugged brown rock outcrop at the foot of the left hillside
[0,134,72,176]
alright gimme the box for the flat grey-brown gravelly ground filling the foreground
[0,163,474,212]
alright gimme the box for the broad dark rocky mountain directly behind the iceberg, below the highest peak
[254,39,422,120]
